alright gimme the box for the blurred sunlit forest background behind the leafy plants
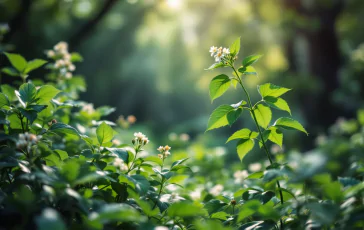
[0,0,364,156]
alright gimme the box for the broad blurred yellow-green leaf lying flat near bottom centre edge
[168,201,207,218]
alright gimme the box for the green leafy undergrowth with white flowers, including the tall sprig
[0,39,364,229]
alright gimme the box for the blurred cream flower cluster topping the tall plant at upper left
[47,42,76,79]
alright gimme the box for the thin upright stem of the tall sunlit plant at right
[230,64,284,229]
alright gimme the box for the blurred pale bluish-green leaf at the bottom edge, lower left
[35,208,67,230]
